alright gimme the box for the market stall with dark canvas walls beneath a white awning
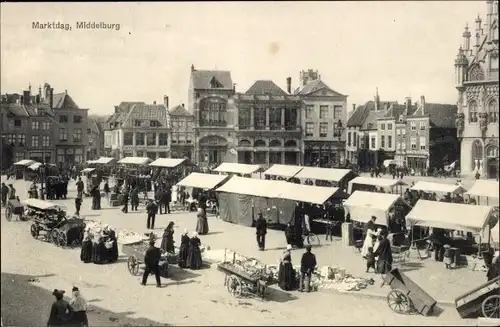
[216,176,295,227]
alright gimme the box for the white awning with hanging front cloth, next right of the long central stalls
[344,191,400,226]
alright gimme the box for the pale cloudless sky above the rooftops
[0,1,486,115]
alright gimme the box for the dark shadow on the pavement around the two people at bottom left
[1,272,168,327]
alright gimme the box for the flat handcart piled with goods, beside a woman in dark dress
[217,250,274,299]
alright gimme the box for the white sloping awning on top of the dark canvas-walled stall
[216,176,283,198]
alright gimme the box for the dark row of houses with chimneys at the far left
[0,83,103,168]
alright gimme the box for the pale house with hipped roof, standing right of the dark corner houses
[104,102,170,160]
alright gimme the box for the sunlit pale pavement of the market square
[1,182,484,326]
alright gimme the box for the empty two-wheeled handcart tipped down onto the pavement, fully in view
[383,268,437,316]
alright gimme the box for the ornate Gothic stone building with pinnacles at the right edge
[455,0,499,178]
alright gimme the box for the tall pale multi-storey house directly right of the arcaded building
[294,69,347,167]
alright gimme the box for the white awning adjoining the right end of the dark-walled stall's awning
[278,181,348,204]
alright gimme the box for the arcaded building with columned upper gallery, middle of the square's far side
[234,79,302,166]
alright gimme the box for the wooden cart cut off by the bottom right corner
[455,277,500,319]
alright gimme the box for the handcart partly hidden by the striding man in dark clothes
[122,238,169,278]
